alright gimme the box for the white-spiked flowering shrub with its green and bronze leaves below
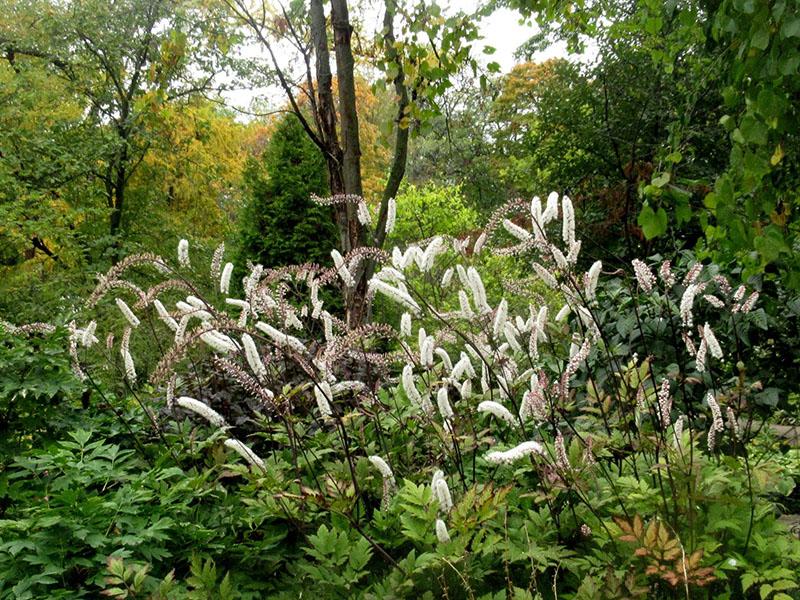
[7,195,800,600]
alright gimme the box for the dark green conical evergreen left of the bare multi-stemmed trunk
[238,114,338,267]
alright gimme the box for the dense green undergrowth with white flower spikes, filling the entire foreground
[0,195,800,600]
